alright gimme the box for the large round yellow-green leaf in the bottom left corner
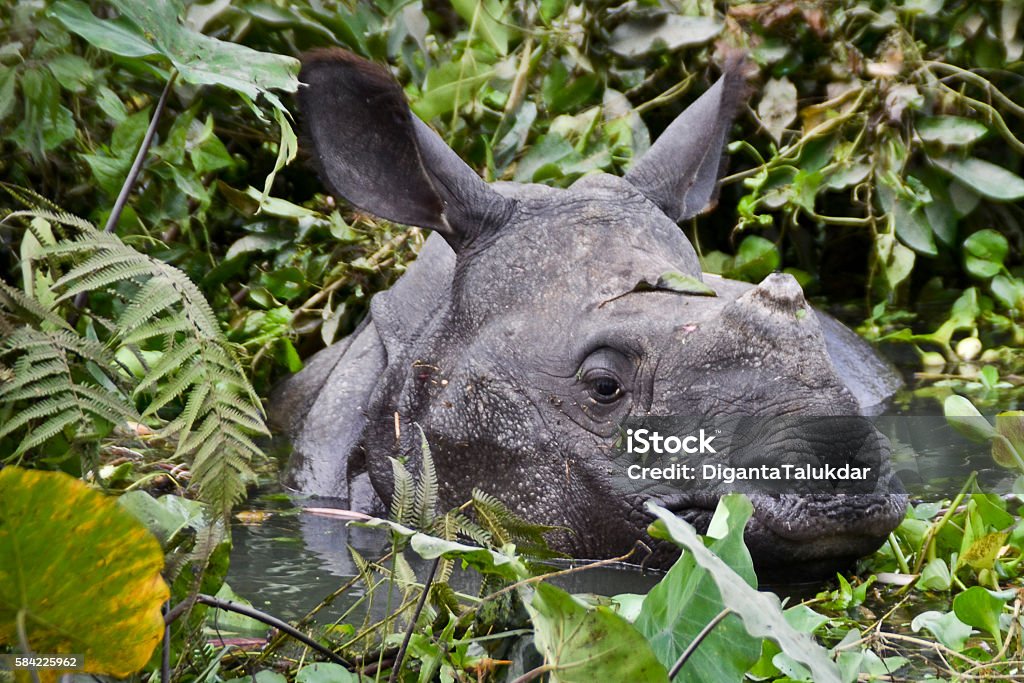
[0,467,168,678]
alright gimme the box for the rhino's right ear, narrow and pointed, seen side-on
[626,57,746,221]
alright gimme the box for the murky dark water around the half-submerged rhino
[228,378,1015,623]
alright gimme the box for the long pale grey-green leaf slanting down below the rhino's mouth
[646,502,840,683]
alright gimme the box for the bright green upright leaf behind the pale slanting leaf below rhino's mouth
[635,496,761,683]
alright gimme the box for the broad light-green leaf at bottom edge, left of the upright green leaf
[523,584,669,683]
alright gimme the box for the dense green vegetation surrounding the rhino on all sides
[0,0,1024,681]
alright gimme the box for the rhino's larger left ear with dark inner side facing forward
[298,49,512,251]
